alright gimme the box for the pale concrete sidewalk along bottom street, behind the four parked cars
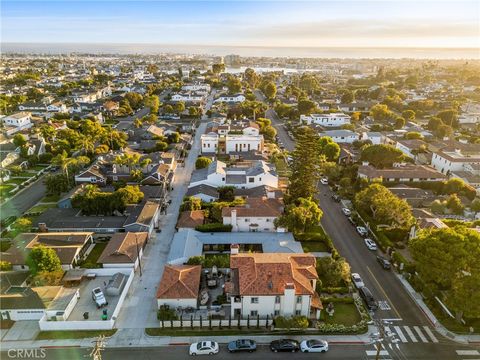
[2,325,377,350]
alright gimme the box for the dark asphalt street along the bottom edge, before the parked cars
[0,344,480,360]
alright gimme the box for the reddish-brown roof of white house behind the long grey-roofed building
[222,197,283,217]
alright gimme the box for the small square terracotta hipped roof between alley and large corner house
[157,265,202,299]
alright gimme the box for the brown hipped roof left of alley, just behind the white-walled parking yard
[97,232,148,264]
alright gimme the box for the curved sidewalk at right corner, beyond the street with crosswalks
[395,273,480,344]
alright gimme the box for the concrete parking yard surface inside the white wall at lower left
[67,276,119,321]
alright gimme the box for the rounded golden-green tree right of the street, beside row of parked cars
[355,184,415,228]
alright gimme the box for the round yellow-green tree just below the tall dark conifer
[275,198,323,233]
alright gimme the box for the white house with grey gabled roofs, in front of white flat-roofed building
[188,160,278,189]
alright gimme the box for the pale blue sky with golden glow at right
[1,0,480,48]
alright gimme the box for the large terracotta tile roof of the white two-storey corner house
[230,253,318,295]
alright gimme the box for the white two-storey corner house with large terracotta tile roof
[225,252,322,318]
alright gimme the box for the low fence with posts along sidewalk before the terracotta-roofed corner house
[160,318,273,328]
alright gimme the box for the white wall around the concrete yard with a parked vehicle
[38,268,135,331]
